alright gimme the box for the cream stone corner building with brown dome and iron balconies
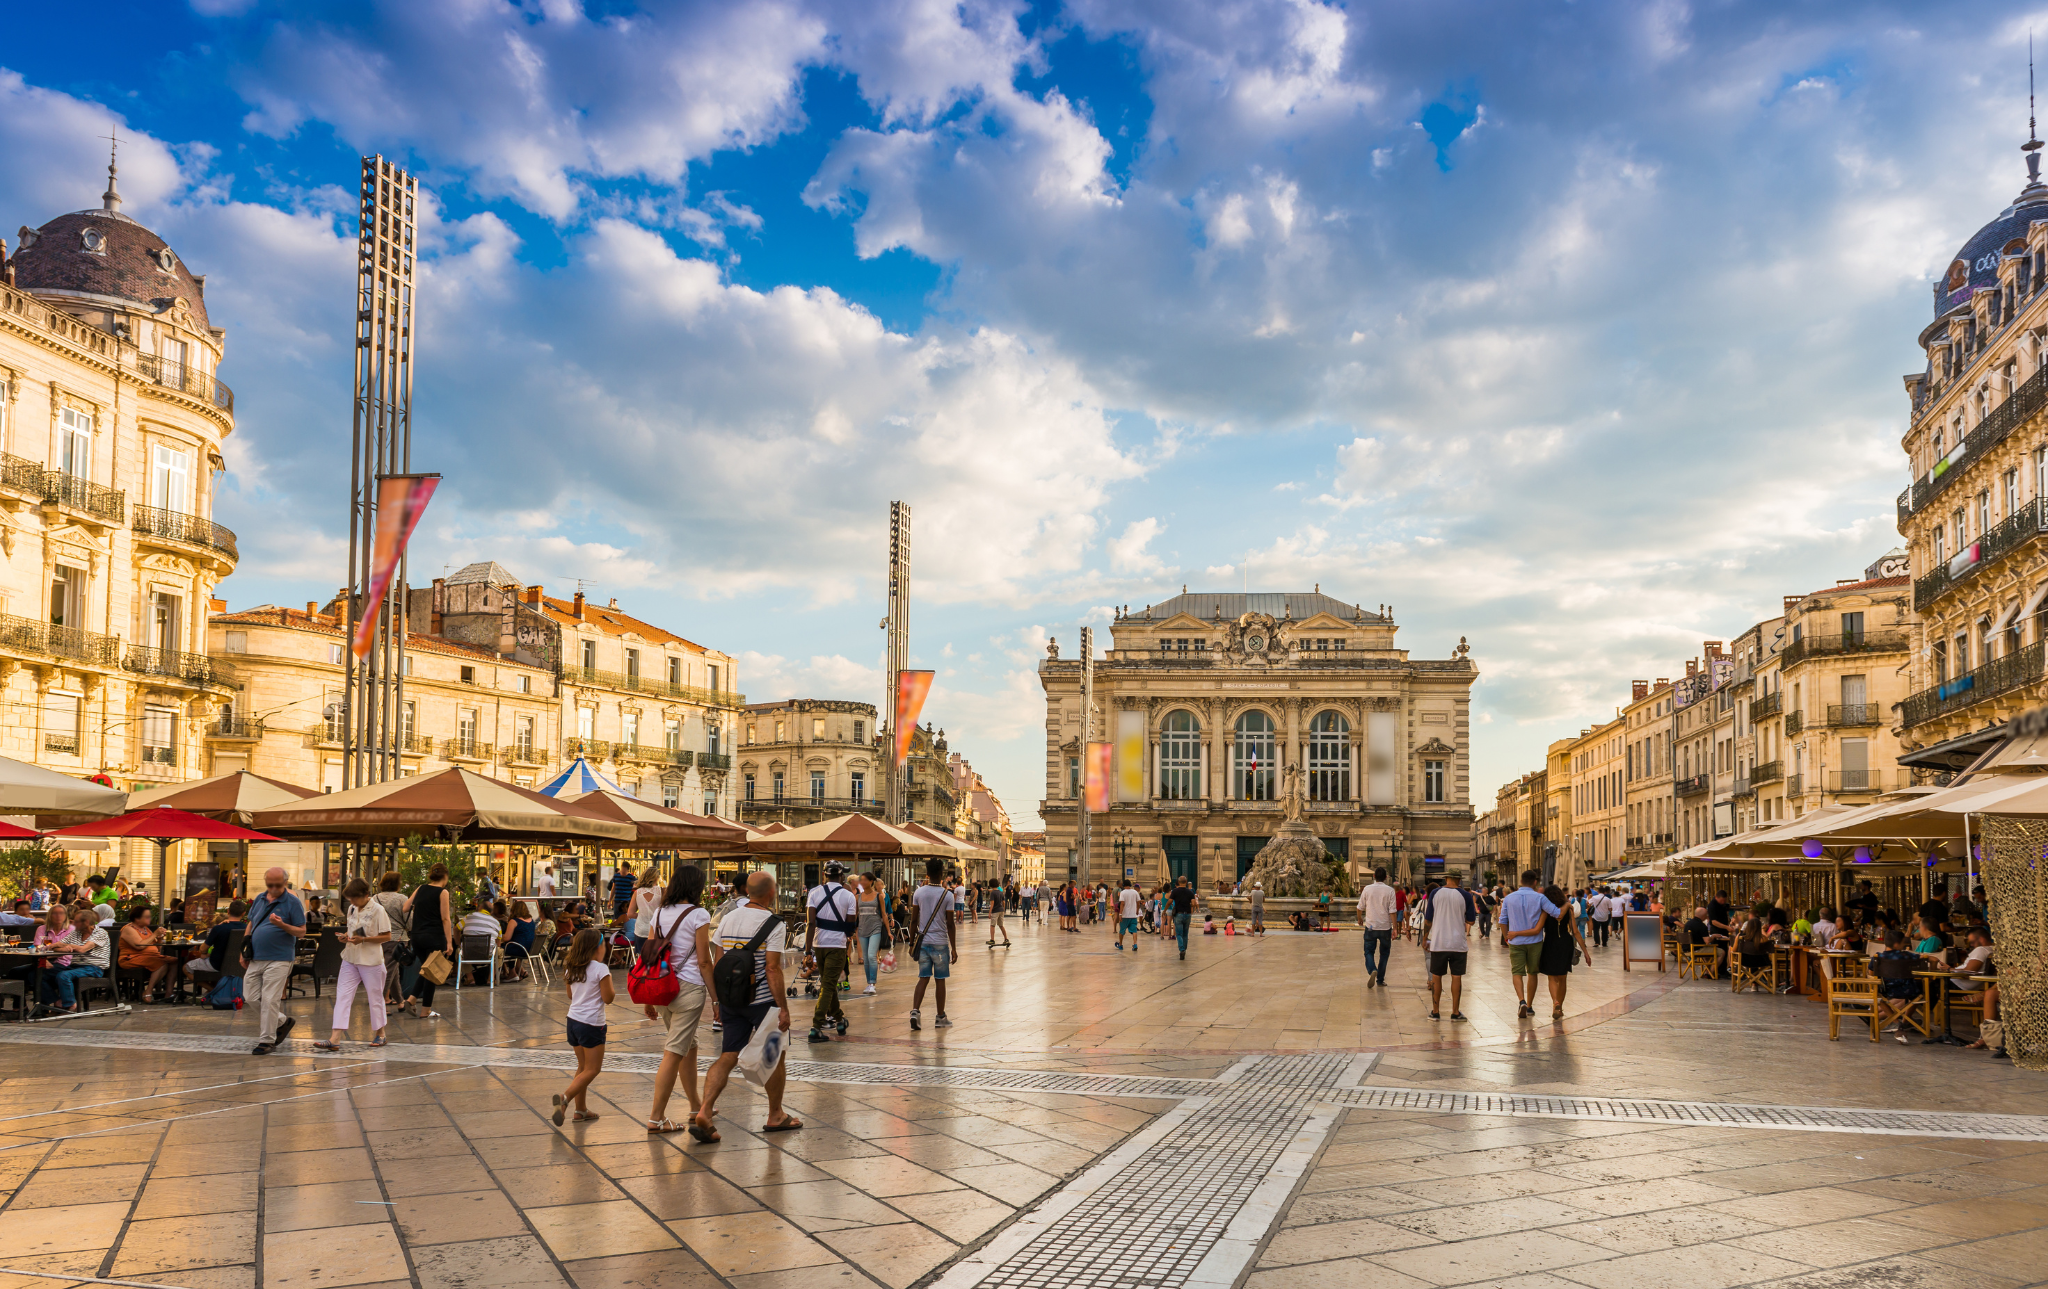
[0,153,240,877]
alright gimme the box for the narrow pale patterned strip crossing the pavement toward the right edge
[1317,1088,2048,1141]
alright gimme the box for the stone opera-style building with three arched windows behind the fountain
[1038,590,1479,889]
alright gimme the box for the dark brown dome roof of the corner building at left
[8,211,207,330]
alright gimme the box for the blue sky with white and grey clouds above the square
[0,0,2048,828]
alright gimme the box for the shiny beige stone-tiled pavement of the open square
[0,924,2048,1289]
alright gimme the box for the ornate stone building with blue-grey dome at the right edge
[1892,123,2048,771]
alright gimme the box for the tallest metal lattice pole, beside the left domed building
[338,156,420,875]
